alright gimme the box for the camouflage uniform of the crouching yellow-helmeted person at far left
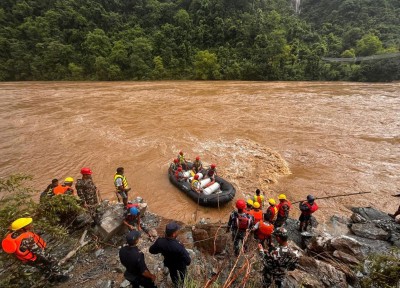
[13,232,62,280]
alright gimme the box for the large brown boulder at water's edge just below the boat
[192,224,230,255]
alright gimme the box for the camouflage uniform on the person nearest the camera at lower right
[262,246,299,288]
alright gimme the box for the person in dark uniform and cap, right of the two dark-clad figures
[149,222,191,287]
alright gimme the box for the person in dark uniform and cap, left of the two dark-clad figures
[119,230,157,288]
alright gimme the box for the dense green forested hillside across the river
[0,0,400,81]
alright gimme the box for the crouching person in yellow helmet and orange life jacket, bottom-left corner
[1,218,69,282]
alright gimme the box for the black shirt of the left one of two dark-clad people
[119,246,148,276]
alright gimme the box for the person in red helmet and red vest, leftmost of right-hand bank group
[226,199,252,256]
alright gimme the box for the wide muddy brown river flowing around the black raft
[0,81,400,223]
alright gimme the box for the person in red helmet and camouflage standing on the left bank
[75,167,100,219]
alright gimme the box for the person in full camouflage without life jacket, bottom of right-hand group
[258,227,299,288]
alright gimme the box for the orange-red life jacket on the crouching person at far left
[1,231,46,262]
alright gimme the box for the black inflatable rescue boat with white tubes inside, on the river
[168,163,236,207]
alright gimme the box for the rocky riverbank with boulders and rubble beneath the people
[57,202,400,288]
